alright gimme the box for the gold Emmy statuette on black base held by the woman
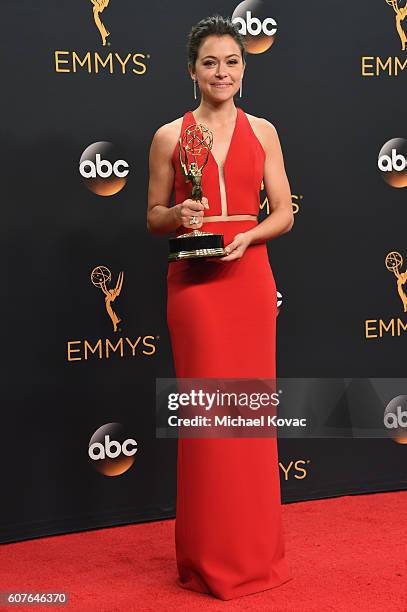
[168,123,227,261]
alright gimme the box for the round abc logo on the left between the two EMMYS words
[79,141,129,196]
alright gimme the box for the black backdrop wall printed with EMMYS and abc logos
[0,0,407,542]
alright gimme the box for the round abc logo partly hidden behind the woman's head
[232,0,277,53]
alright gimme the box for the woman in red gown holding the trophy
[147,15,293,600]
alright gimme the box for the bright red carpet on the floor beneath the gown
[0,491,407,612]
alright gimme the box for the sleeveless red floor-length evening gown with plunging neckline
[167,108,292,600]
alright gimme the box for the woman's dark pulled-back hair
[187,15,246,67]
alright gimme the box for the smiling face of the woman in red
[190,34,244,101]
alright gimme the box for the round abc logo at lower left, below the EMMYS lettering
[88,423,138,476]
